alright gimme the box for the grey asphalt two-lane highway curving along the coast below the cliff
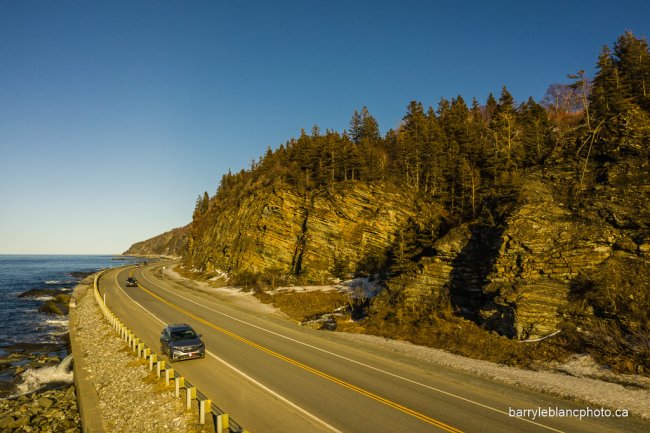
[99,263,649,433]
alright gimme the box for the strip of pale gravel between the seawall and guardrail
[70,274,203,433]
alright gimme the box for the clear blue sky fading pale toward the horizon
[0,0,650,253]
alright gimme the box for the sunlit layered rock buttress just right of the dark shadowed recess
[480,180,620,339]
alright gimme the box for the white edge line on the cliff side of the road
[142,271,564,433]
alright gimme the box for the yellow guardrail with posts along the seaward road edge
[93,269,248,433]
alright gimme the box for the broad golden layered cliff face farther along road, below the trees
[184,183,414,282]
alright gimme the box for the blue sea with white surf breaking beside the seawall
[0,254,139,398]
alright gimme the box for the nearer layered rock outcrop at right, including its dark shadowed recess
[389,157,650,339]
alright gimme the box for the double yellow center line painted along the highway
[138,283,463,433]
